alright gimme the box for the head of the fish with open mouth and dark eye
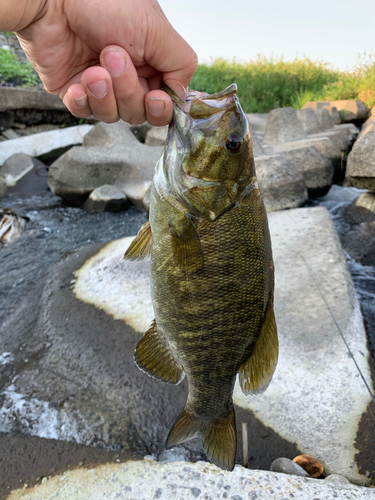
[164,84,254,220]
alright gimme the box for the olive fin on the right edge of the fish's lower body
[239,294,279,395]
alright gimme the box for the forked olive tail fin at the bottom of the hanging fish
[166,406,237,471]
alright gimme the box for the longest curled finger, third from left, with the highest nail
[100,45,149,125]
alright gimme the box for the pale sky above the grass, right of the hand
[159,0,375,70]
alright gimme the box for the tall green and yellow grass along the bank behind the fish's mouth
[190,54,375,113]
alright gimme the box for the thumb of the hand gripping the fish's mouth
[144,5,198,97]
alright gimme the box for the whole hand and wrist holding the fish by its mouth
[0,0,197,126]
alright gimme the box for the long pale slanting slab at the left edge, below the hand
[0,125,92,165]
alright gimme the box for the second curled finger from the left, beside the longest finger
[81,66,120,123]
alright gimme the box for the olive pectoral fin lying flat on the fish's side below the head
[169,214,204,272]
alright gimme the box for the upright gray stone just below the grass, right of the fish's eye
[262,108,307,146]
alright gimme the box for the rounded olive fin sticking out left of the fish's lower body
[134,320,185,384]
